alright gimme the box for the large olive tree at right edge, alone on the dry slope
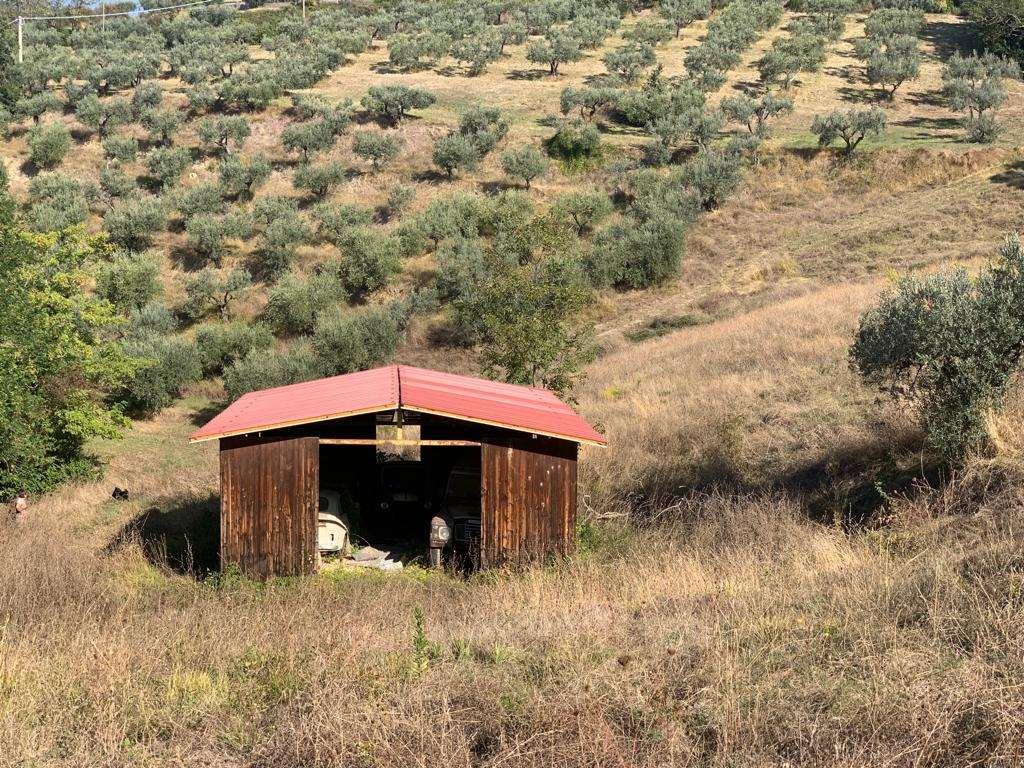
[850,236,1024,460]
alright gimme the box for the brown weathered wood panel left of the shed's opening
[220,437,319,579]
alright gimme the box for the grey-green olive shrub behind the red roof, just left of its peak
[312,307,403,376]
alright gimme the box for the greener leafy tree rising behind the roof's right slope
[471,260,594,395]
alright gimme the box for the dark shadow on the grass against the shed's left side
[104,494,220,579]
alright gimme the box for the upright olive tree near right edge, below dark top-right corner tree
[942,53,1021,142]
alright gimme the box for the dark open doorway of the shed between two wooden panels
[318,444,481,569]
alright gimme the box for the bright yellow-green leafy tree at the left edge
[0,225,134,496]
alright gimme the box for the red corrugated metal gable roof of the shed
[191,366,606,445]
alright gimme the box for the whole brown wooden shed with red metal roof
[190,366,605,579]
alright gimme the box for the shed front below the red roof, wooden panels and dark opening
[220,409,578,578]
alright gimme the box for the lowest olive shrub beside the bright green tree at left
[114,336,202,417]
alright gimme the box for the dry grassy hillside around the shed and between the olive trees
[0,4,1024,768]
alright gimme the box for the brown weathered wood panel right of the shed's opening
[480,438,577,565]
